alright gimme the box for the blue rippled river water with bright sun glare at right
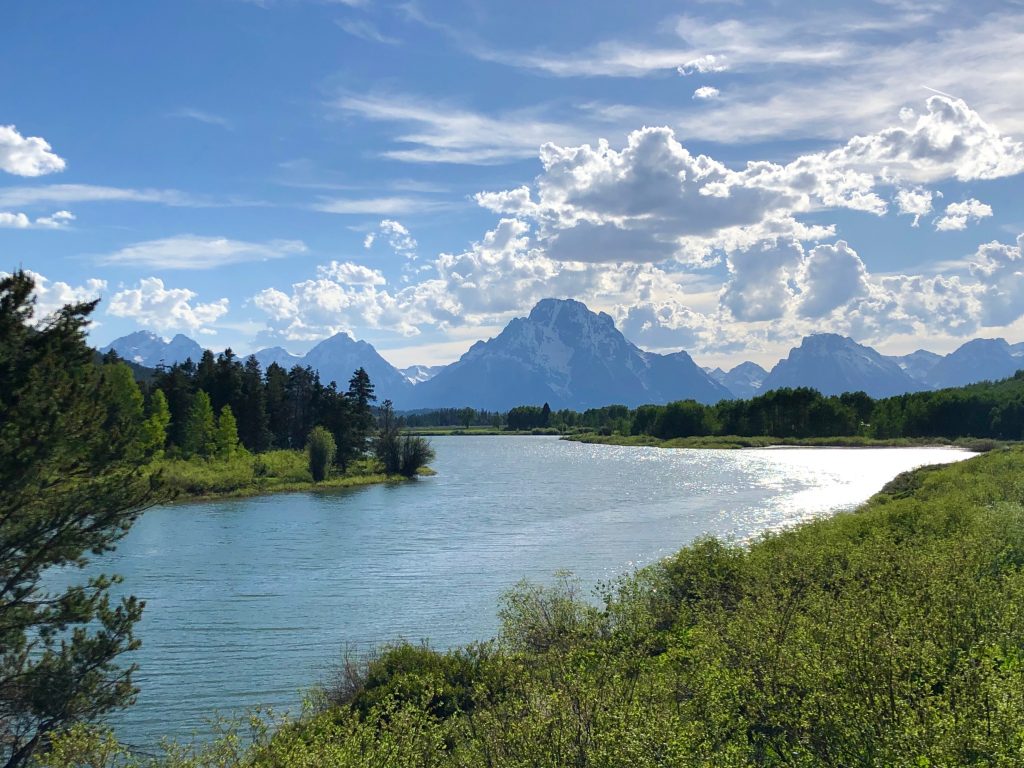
[56,437,969,743]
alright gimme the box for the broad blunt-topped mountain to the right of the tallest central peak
[761,334,928,397]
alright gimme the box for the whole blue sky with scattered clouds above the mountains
[0,0,1024,367]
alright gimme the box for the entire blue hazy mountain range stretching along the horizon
[100,299,1024,411]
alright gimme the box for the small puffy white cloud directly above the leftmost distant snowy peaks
[106,278,228,333]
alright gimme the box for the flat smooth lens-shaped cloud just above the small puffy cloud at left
[99,234,306,269]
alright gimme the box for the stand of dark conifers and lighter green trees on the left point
[112,349,376,470]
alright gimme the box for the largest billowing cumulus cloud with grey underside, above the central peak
[476,128,839,263]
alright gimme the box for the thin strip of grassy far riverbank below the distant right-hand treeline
[562,432,1013,454]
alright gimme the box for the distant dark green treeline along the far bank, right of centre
[520,371,1024,440]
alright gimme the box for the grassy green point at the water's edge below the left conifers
[153,451,434,502]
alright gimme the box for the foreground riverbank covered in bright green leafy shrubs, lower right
[48,447,1024,768]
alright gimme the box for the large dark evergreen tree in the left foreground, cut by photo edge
[0,271,154,768]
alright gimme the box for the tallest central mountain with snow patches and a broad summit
[403,299,731,410]
